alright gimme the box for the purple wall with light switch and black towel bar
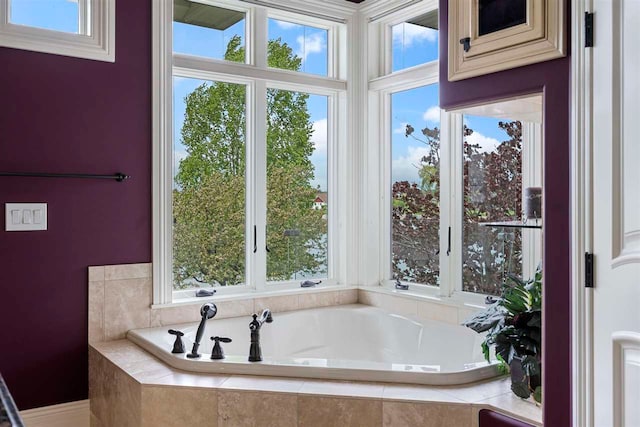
[0,0,151,410]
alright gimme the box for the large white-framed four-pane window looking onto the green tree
[154,0,346,303]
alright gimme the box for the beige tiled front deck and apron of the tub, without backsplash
[89,340,541,427]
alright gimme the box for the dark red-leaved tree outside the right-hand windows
[392,121,522,294]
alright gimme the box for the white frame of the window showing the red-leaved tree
[365,1,543,306]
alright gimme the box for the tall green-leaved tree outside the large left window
[173,37,326,287]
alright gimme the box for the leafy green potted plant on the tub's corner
[463,266,542,403]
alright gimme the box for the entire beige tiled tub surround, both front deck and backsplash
[89,264,542,427]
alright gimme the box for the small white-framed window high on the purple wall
[0,0,115,62]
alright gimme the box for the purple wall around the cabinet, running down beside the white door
[440,0,571,426]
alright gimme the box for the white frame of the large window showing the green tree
[152,0,348,305]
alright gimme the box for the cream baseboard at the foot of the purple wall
[20,400,89,427]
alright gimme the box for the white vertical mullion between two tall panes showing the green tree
[247,80,267,290]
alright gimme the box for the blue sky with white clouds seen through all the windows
[15,0,506,190]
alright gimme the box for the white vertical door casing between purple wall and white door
[570,0,594,427]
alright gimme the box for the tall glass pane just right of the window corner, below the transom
[391,84,440,286]
